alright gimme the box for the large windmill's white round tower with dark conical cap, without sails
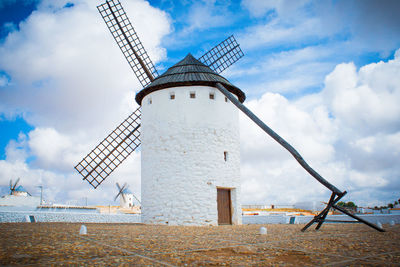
[136,54,245,225]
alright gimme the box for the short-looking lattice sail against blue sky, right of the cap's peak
[199,35,244,73]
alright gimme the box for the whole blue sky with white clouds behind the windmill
[0,0,400,207]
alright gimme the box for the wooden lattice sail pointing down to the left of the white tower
[75,108,141,188]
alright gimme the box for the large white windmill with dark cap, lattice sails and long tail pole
[75,0,383,231]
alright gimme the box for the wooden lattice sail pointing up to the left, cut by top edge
[97,0,158,87]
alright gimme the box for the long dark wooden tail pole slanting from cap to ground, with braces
[216,83,384,232]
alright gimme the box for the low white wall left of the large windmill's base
[0,211,141,223]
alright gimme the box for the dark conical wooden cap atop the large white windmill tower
[135,53,246,105]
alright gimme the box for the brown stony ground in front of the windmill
[0,223,400,266]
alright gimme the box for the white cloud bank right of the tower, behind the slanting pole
[241,50,400,205]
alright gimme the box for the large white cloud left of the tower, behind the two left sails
[0,0,171,204]
